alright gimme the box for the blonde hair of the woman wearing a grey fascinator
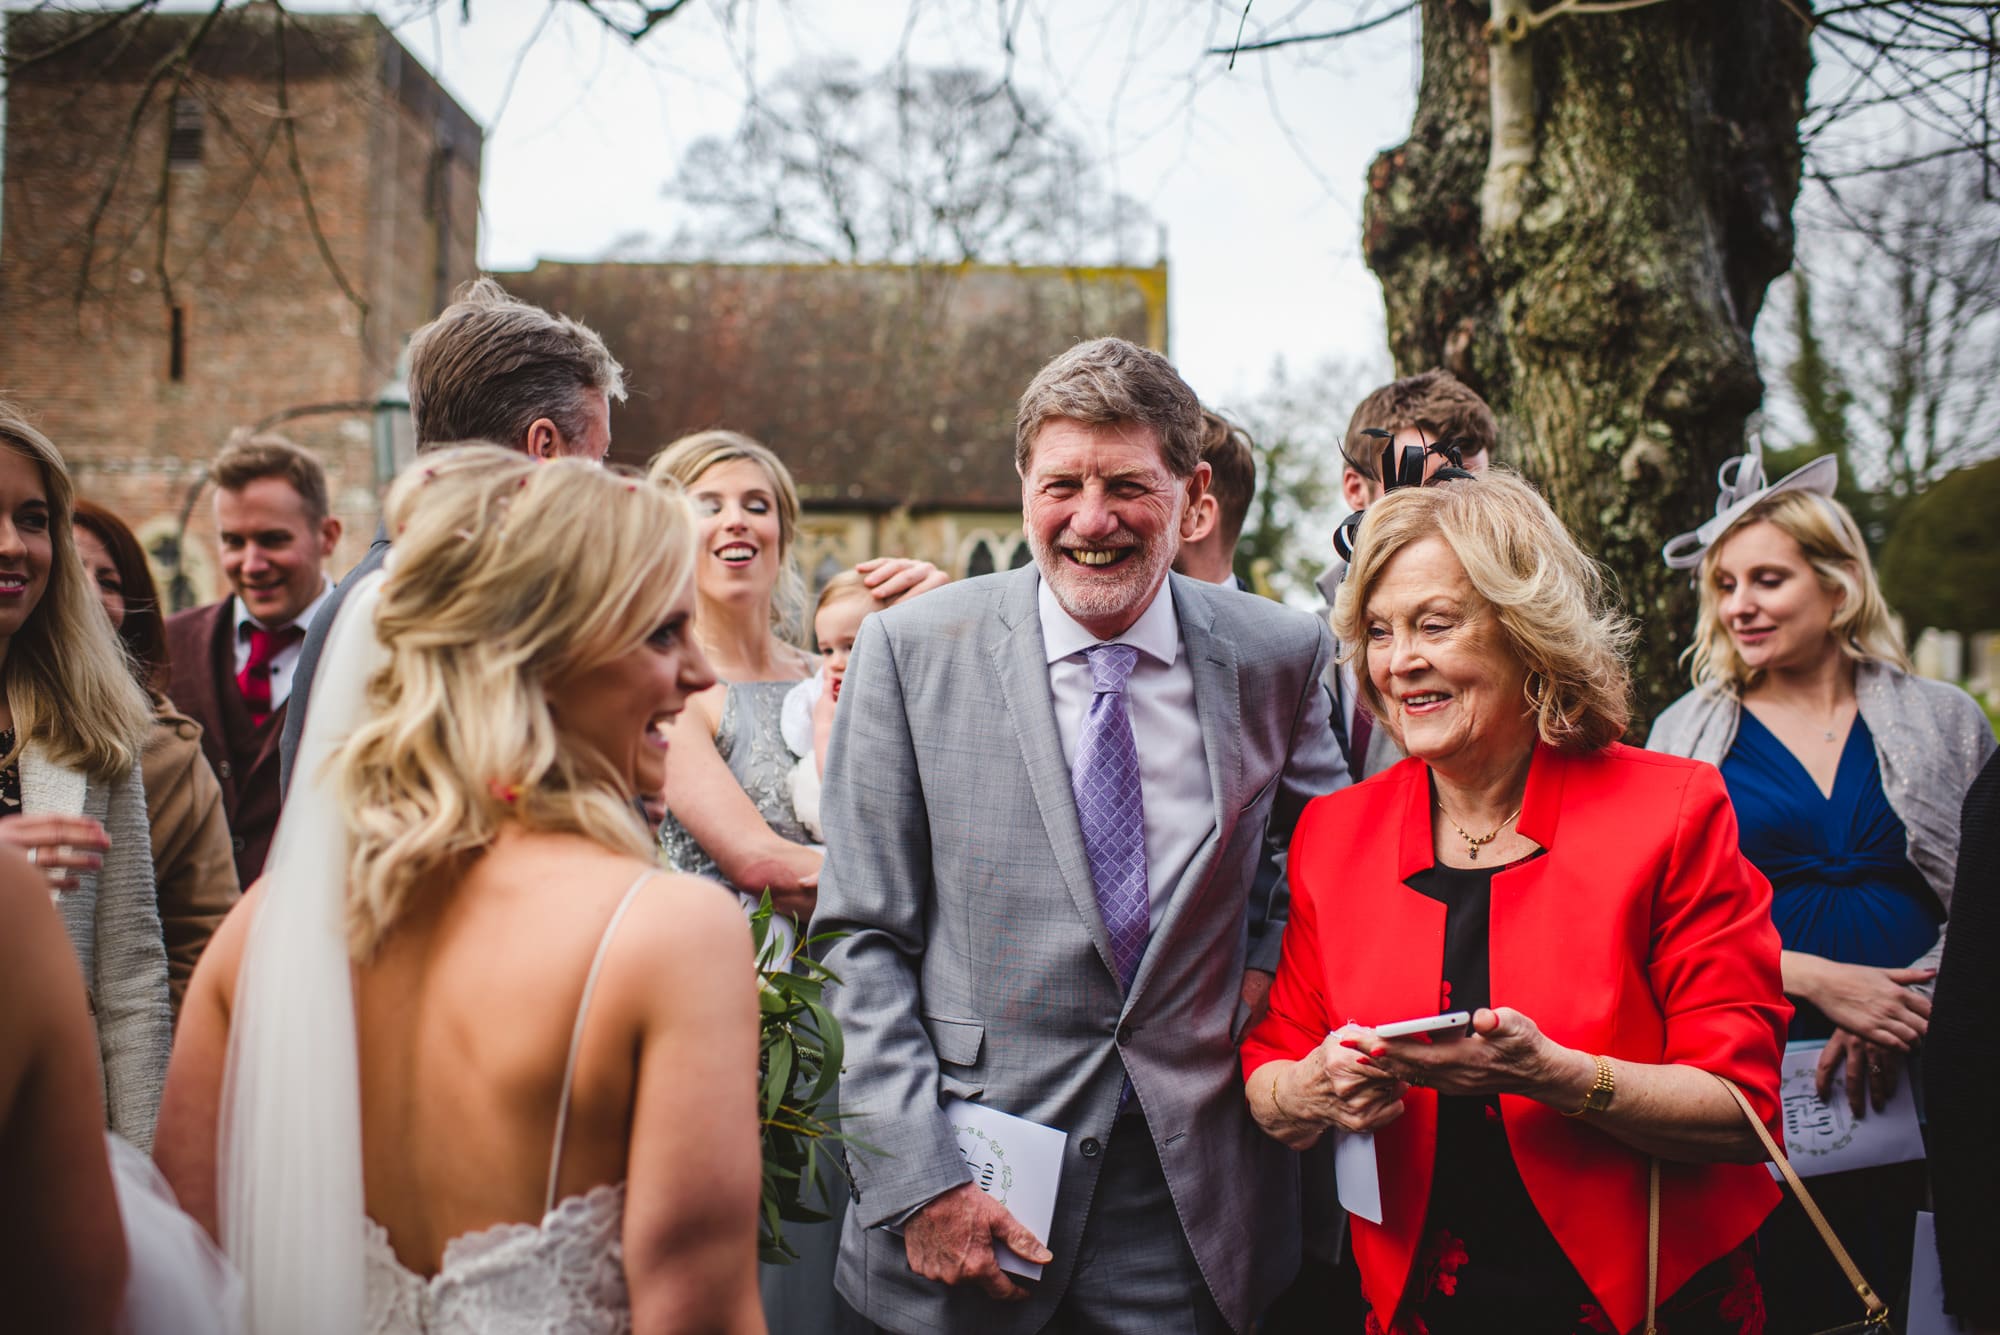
[1682,492,1910,695]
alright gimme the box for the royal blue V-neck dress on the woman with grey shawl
[1722,709,1944,1039]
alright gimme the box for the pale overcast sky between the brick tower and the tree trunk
[368,0,1418,406]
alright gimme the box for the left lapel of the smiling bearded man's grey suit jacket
[988,566,1118,977]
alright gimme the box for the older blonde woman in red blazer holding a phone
[1244,474,1790,1335]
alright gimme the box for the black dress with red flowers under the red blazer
[1366,853,1764,1335]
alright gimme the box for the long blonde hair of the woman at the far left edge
[0,400,152,783]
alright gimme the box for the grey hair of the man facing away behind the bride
[410,278,624,450]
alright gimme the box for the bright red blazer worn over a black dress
[1242,745,1792,1331]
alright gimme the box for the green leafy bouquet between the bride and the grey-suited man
[750,891,866,1265]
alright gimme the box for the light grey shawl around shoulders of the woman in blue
[1646,662,1994,991]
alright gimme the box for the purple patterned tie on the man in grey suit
[1070,644,1150,987]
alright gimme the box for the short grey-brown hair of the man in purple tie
[1014,338,1202,478]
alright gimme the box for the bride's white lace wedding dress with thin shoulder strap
[362,871,652,1335]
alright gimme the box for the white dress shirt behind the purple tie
[1038,580,1216,925]
